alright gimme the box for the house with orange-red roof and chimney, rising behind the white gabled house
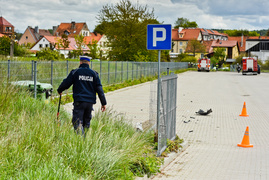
[54,21,90,37]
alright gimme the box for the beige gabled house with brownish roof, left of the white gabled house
[19,26,52,45]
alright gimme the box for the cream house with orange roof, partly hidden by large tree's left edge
[84,33,110,58]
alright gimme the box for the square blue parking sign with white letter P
[147,24,172,50]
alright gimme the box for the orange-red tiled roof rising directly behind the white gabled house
[54,22,86,37]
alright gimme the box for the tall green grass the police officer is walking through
[0,82,161,179]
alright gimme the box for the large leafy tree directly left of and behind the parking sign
[97,0,159,61]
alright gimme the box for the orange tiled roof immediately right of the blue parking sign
[172,28,201,41]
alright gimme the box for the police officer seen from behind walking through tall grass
[57,56,107,134]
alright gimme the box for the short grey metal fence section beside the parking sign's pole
[149,74,177,156]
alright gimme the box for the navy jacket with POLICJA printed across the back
[57,64,106,106]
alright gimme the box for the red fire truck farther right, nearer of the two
[242,57,260,75]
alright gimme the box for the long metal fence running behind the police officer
[0,60,188,94]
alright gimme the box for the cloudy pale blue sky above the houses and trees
[0,0,269,33]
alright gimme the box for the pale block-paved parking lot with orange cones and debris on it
[62,72,269,180]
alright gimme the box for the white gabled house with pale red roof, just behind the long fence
[31,36,89,57]
